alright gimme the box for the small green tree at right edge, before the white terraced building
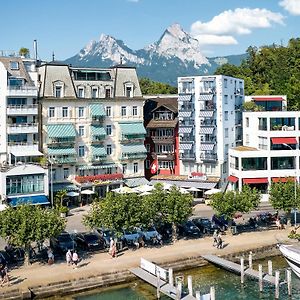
[269,179,300,213]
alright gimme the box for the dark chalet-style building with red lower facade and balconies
[144,95,179,179]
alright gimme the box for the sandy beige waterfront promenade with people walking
[0,230,289,291]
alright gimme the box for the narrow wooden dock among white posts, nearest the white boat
[202,254,275,285]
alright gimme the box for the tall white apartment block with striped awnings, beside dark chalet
[178,75,244,187]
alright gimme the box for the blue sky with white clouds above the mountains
[0,0,300,60]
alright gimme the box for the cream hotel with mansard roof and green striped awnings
[39,62,146,196]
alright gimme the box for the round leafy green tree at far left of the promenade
[0,205,66,264]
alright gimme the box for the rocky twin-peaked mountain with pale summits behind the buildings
[65,24,245,85]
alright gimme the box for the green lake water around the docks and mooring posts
[55,257,300,300]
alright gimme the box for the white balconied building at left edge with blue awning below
[0,56,49,206]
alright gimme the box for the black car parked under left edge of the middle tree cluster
[75,232,106,251]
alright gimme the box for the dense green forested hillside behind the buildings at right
[215,38,300,110]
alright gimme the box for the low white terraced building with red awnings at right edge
[228,96,300,199]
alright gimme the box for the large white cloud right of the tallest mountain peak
[191,8,284,36]
